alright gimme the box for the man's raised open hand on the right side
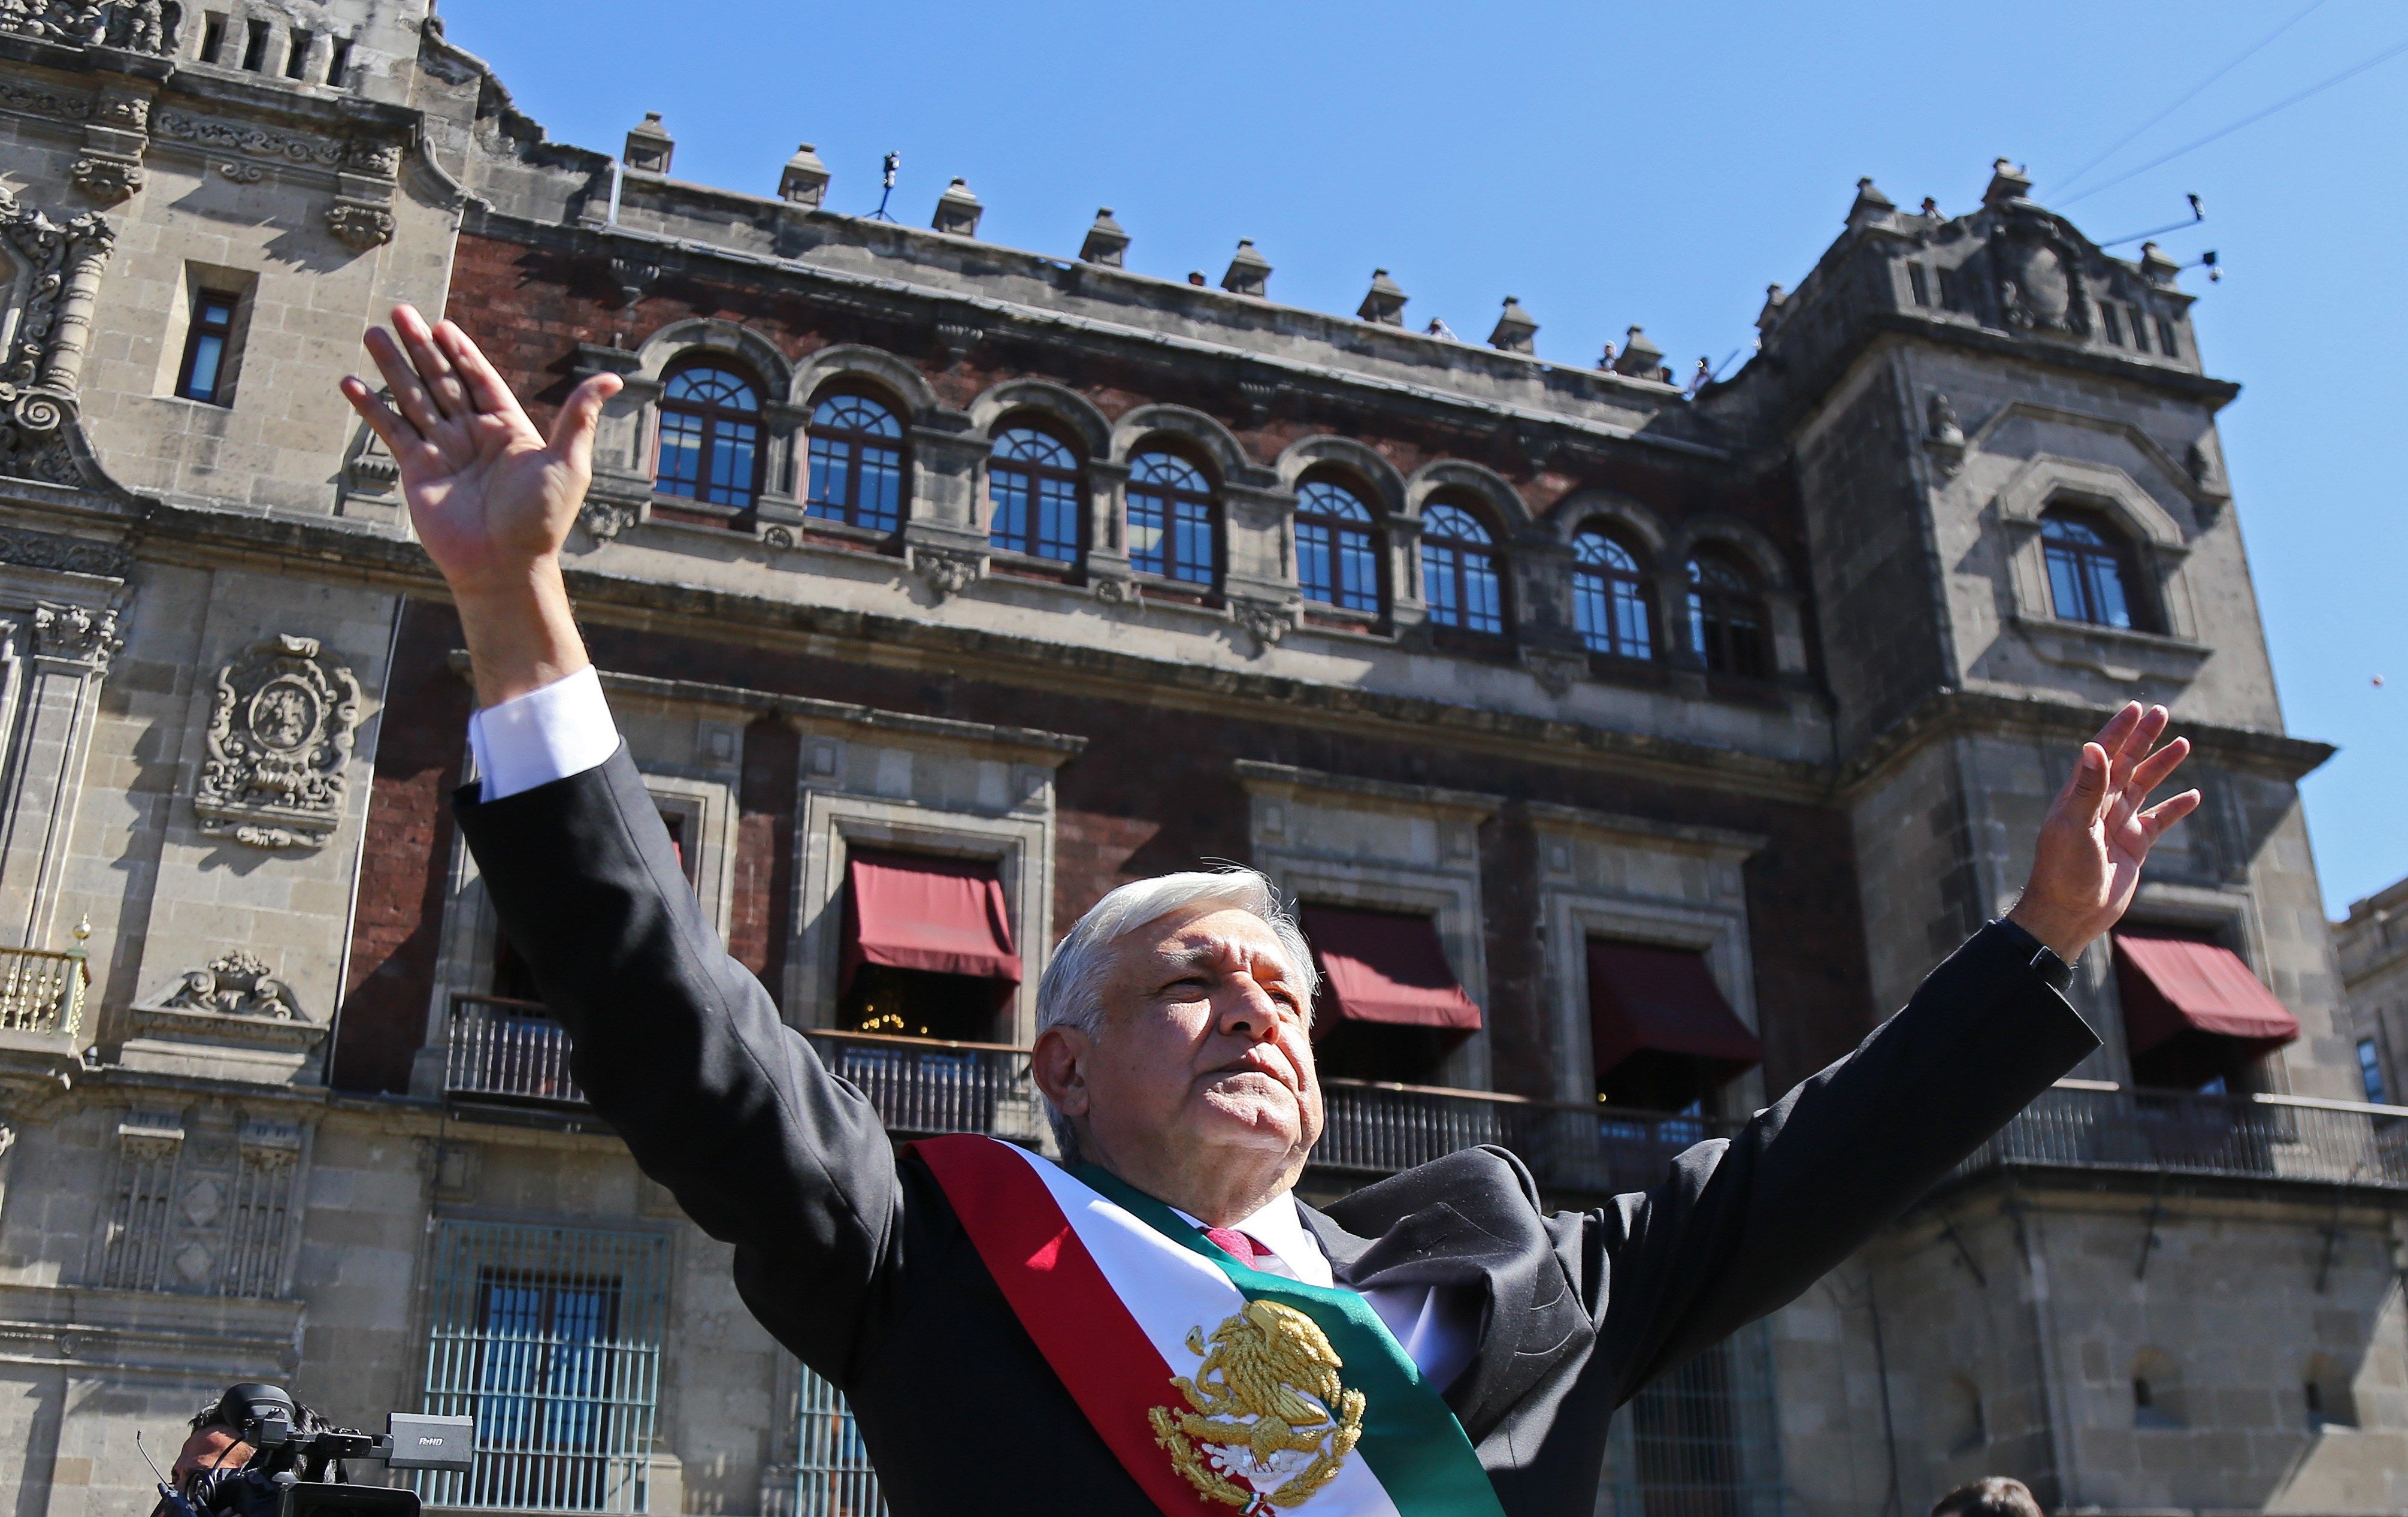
[2006,701,2198,963]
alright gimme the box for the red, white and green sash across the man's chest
[913,1134,1502,1517]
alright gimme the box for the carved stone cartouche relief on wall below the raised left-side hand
[193,633,359,850]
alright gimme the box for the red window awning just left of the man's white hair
[838,848,1021,992]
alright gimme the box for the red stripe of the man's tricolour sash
[910,1134,1199,1517]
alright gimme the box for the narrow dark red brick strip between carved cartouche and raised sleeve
[332,600,474,1091]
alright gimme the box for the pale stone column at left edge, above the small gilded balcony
[0,605,120,949]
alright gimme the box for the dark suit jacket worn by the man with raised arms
[458,749,2097,1517]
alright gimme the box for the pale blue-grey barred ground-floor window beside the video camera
[419,1221,670,1512]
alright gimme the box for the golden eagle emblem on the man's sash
[1146,1300,1363,1517]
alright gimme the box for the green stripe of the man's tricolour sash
[1072,1163,1505,1517]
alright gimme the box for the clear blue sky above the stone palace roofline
[443,0,2408,915]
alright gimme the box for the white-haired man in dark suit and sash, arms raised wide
[344,308,2198,1517]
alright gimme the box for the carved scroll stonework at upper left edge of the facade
[0,182,118,484]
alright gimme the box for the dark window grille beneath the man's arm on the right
[1606,1322,1784,1517]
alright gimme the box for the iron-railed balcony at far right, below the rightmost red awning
[1955,1081,2408,1192]
